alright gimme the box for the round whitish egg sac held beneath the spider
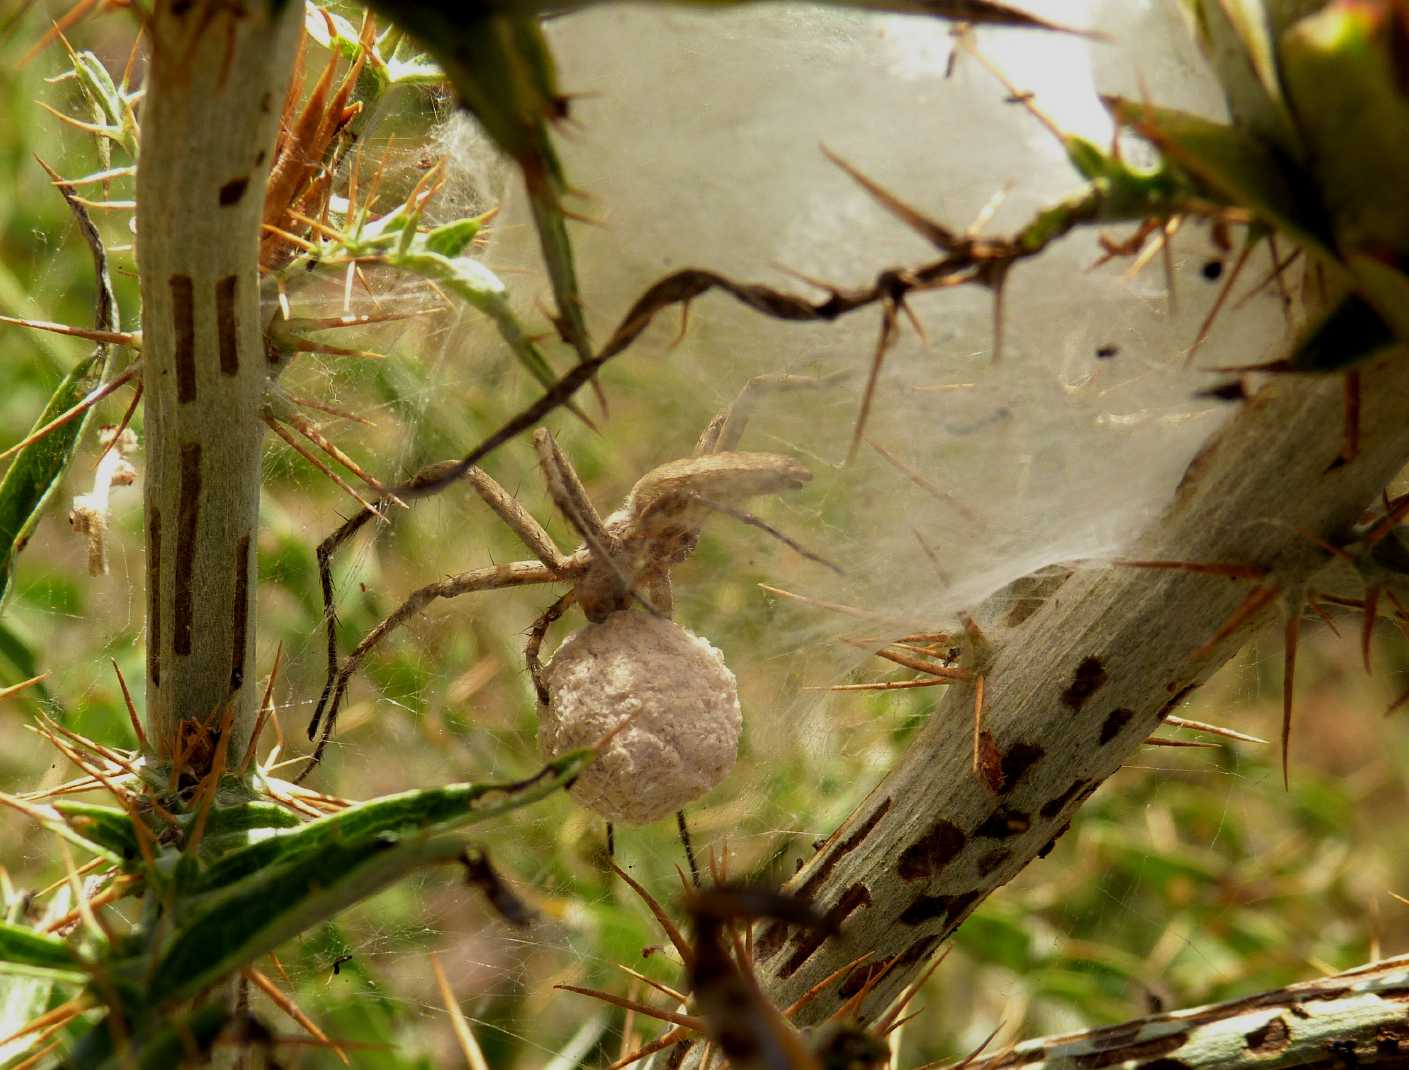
[538,610,744,825]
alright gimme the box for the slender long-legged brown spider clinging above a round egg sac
[299,374,822,780]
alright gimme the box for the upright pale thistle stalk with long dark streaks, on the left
[137,0,303,757]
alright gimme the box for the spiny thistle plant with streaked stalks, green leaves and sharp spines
[0,0,1409,1067]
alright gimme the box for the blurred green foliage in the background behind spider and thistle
[0,7,1409,1070]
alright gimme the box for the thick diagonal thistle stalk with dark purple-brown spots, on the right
[732,347,1409,1037]
